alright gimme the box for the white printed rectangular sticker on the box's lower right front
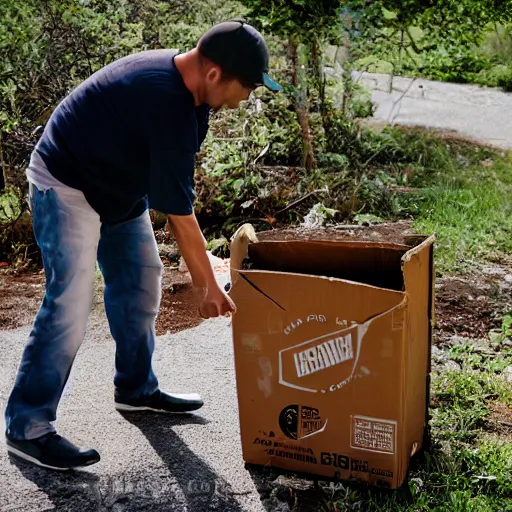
[350,416,397,454]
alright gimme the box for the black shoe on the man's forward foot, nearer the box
[115,391,204,413]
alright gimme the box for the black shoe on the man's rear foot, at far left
[5,432,100,471]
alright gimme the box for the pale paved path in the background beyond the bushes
[352,72,512,149]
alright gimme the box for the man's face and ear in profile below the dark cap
[202,67,255,112]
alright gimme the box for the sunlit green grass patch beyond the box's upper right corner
[414,154,512,272]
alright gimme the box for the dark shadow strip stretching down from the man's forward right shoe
[122,413,243,512]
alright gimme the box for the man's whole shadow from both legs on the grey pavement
[10,412,242,512]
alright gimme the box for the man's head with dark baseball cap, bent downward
[175,20,281,110]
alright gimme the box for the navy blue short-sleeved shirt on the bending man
[35,50,209,222]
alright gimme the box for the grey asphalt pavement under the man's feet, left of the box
[0,306,268,512]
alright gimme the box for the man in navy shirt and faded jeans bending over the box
[5,20,280,469]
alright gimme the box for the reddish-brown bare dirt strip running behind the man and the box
[0,222,512,346]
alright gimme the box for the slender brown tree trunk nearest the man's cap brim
[288,36,315,171]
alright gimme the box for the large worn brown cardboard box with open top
[230,228,434,488]
